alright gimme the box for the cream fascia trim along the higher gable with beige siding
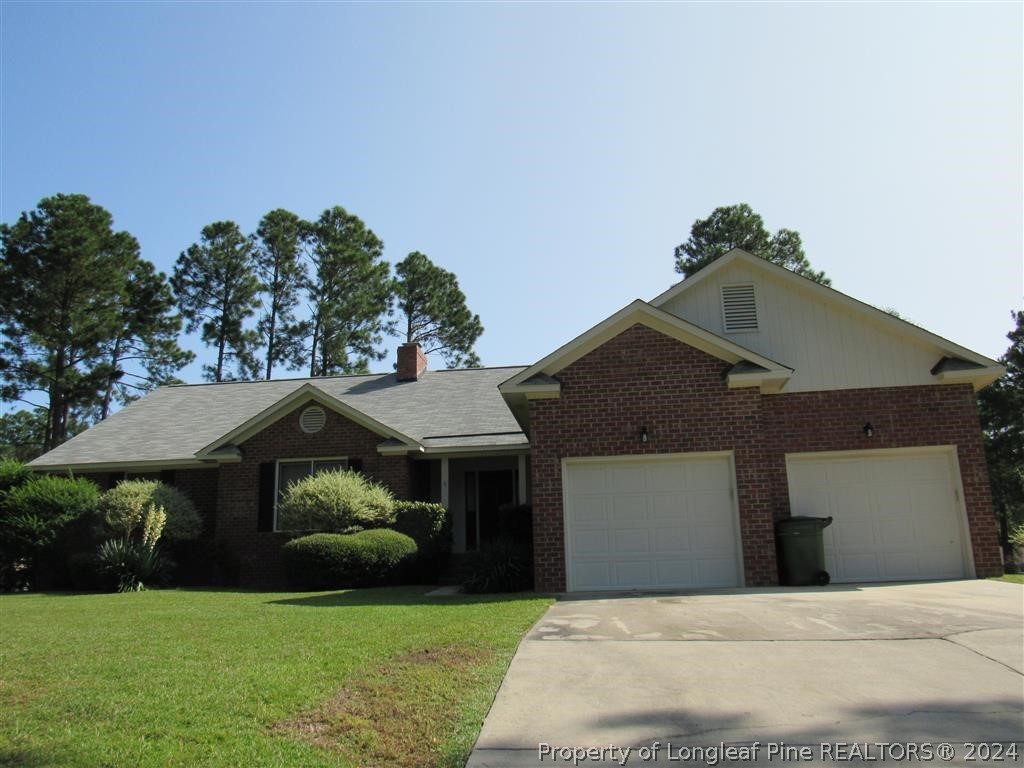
[650,248,998,368]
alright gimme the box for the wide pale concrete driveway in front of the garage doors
[468,581,1024,768]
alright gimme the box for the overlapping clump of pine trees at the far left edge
[0,195,187,450]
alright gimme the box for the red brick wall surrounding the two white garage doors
[529,325,999,592]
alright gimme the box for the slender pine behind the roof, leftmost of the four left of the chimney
[171,221,259,381]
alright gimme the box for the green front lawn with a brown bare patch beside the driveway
[0,588,551,768]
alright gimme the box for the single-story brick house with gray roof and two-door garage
[32,250,1002,592]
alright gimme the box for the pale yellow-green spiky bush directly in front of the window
[278,470,394,534]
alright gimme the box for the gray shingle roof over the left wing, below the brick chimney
[31,367,528,467]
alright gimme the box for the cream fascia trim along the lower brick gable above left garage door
[498,299,793,387]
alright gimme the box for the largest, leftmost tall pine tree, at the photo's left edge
[0,195,139,450]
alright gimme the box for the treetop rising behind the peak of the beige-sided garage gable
[676,203,831,286]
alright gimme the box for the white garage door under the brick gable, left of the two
[562,455,740,592]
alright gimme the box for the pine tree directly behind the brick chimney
[395,251,483,368]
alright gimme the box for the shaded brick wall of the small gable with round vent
[216,402,410,587]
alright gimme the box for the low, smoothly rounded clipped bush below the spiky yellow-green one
[284,528,416,590]
